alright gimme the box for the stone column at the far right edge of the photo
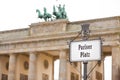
[112,46,120,80]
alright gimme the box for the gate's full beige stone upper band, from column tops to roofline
[0,17,120,54]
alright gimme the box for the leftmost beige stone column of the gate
[8,54,16,80]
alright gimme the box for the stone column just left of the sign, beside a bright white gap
[59,50,67,80]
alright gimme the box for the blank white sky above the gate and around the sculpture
[0,0,120,31]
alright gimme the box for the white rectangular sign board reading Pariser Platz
[70,40,101,62]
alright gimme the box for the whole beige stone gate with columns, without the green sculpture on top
[0,16,120,80]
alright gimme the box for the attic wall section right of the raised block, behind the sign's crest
[67,17,120,31]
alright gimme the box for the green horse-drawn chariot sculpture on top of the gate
[36,4,67,21]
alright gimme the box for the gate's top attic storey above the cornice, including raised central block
[0,16,120,41]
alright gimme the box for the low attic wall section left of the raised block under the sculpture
[0,28,29,42]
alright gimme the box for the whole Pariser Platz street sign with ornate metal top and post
[70,24,101,80]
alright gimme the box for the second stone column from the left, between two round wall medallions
[28,52,37,80]
